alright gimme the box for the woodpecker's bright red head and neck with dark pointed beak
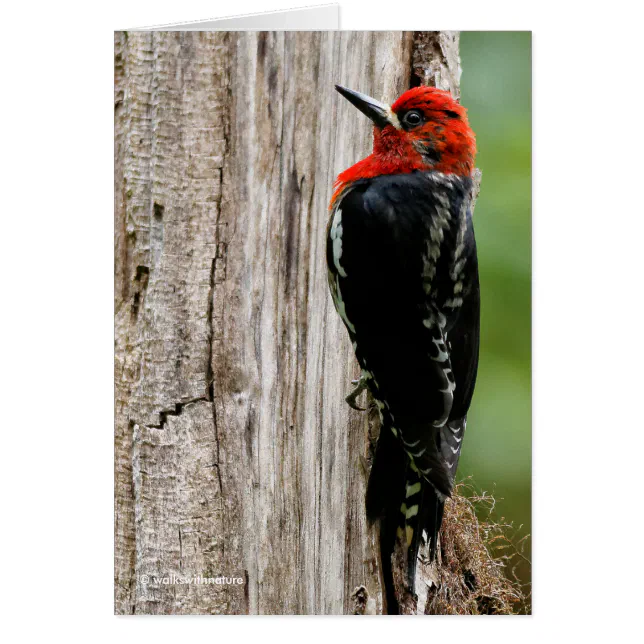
[334,85,476,203]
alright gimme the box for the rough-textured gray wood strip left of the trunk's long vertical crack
[115,33,233,613]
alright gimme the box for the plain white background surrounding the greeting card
[0,0,644,643]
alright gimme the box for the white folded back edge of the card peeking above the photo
[123,3,340,31]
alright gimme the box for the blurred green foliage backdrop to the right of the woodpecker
[459,31,532,578]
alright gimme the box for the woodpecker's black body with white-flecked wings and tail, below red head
[327,171,479,602]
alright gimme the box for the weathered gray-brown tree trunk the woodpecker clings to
[115,32,468,614]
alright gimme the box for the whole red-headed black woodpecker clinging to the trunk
[326,85,480,613]
